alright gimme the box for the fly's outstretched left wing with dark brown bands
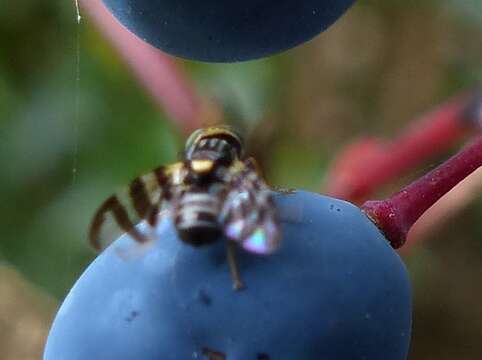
[89,164,177,250]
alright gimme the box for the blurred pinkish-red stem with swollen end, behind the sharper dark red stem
[324,91,482,202]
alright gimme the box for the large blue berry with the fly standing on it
[44,191,412,360]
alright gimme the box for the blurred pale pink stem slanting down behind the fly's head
[80,0,205,133]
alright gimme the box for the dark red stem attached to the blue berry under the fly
[361,136,482,249]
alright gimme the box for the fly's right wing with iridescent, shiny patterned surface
[221,159,281,254]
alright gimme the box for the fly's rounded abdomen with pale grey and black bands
[174,191,222,246]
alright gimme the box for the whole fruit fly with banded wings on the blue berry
[89,126,281,289]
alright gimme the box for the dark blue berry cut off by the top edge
[104,0,355,62]
